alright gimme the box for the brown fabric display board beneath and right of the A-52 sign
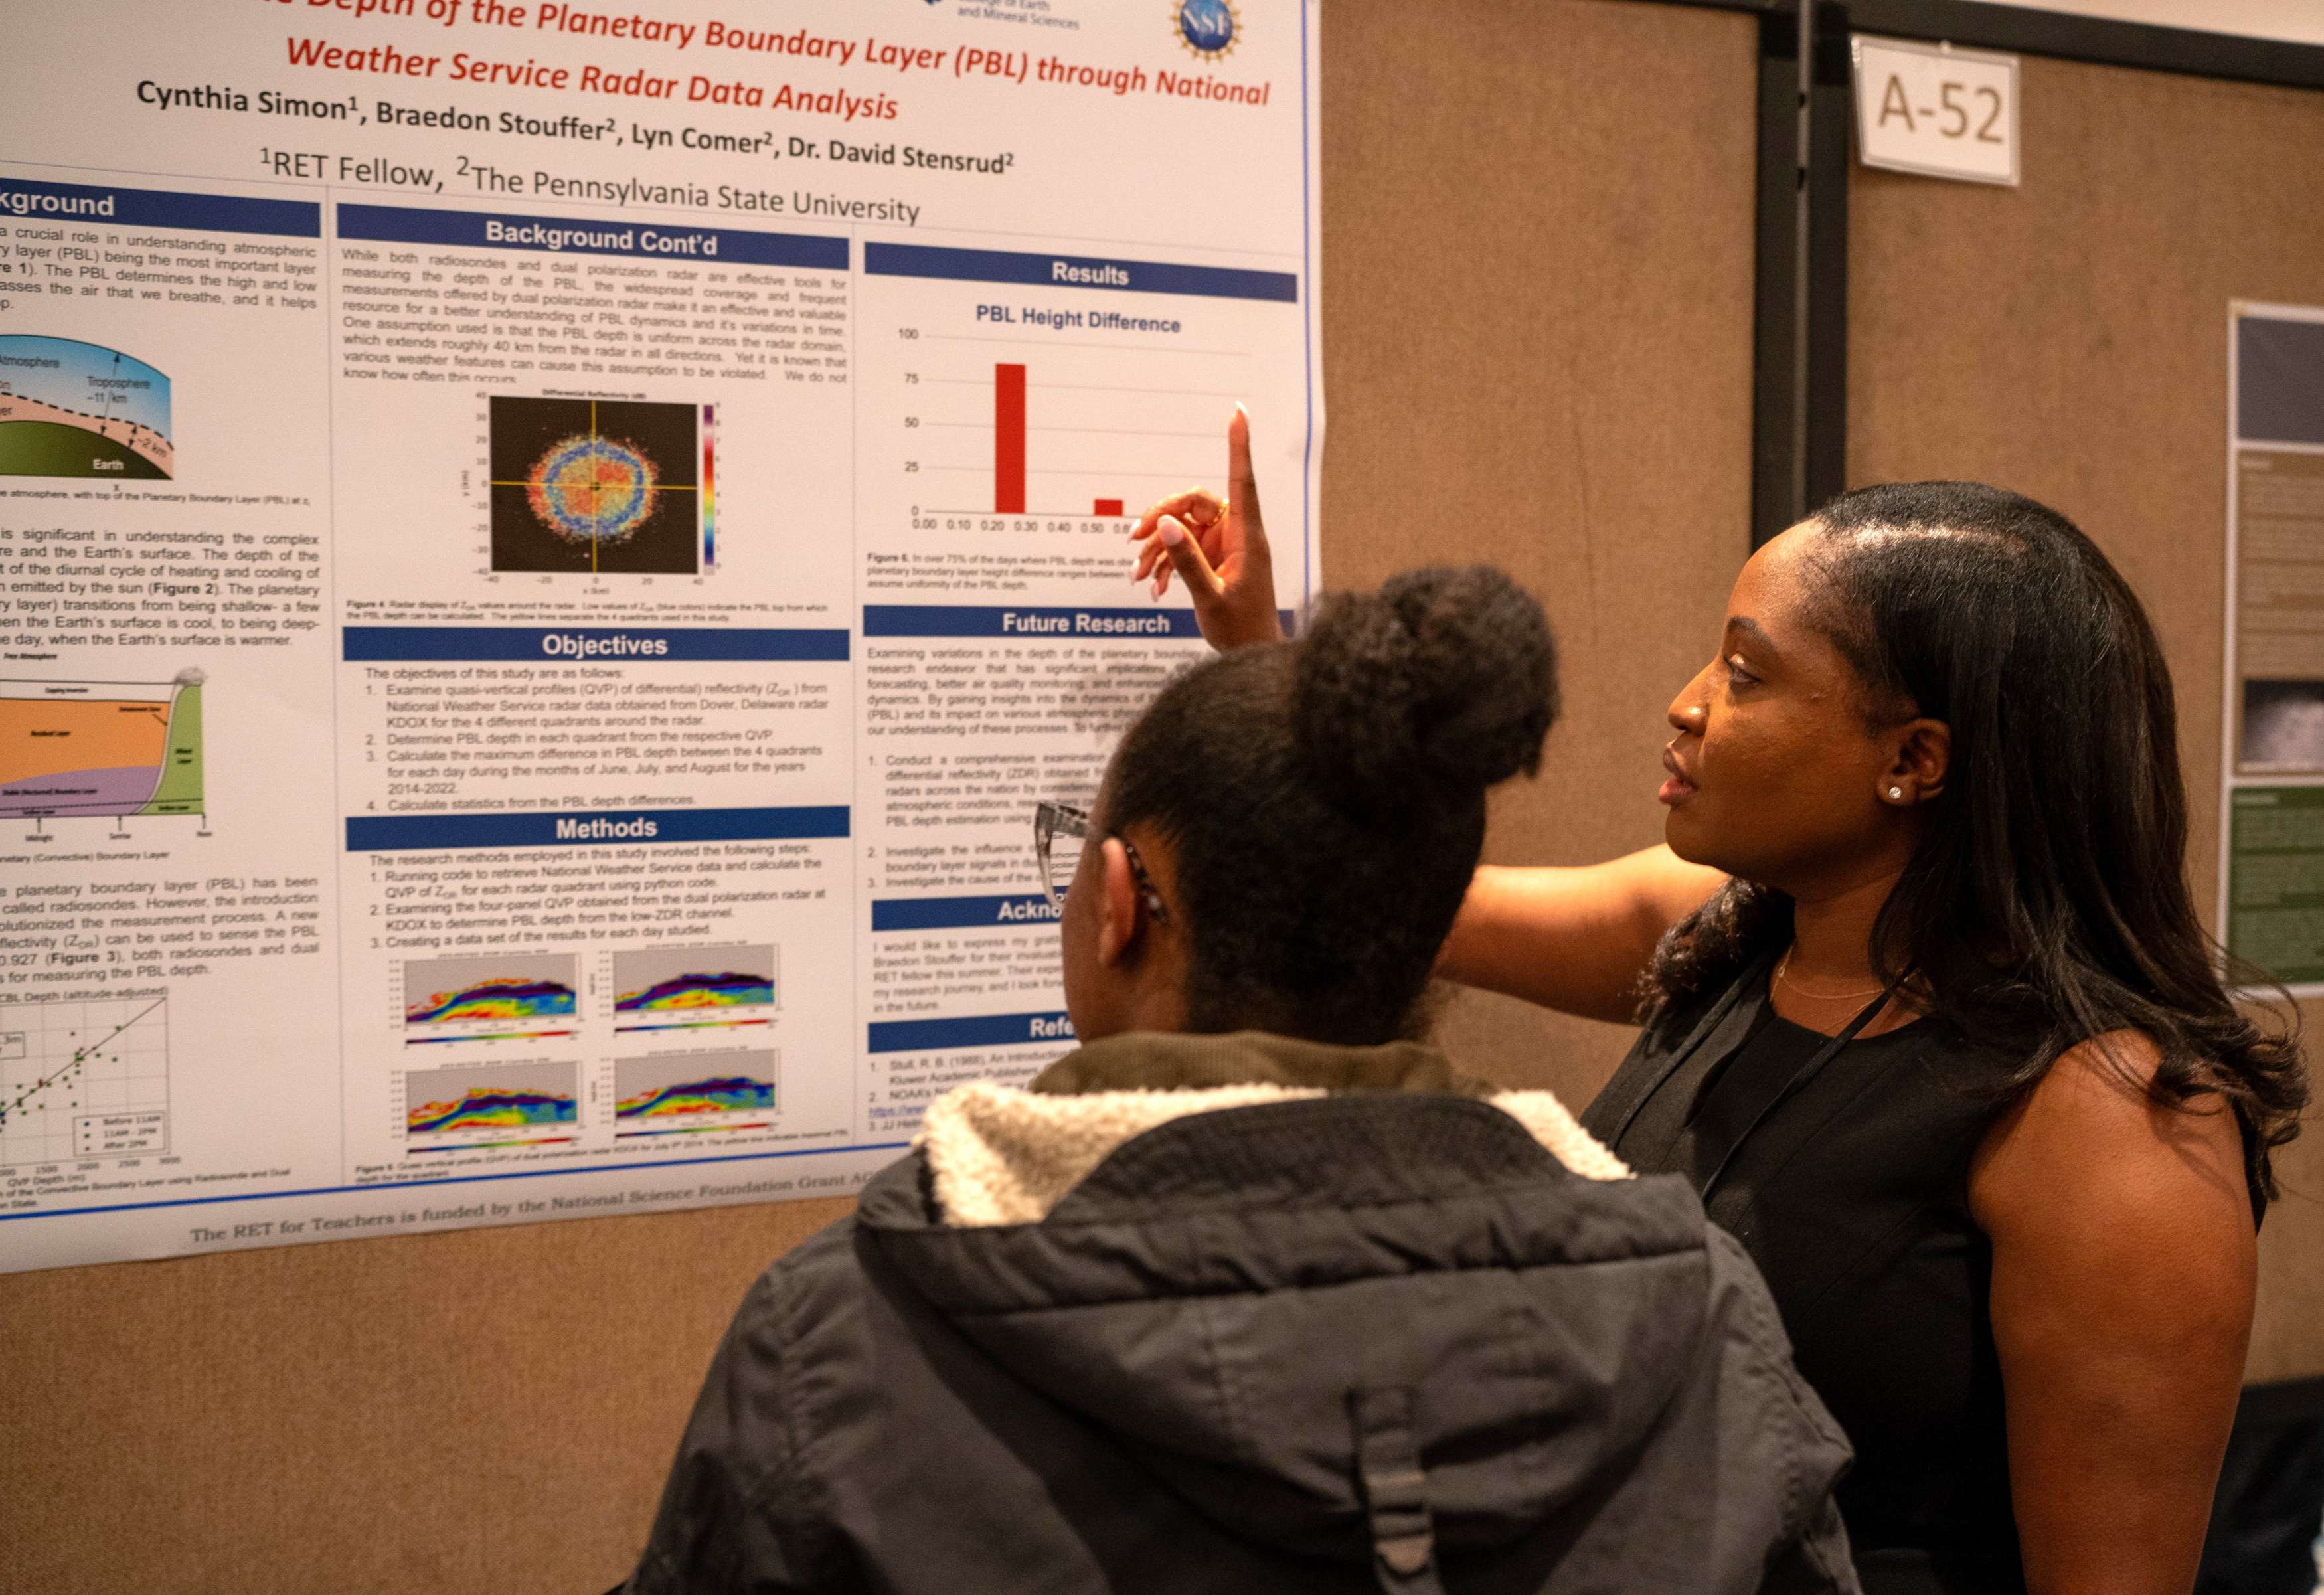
[1848,58,2324,1381]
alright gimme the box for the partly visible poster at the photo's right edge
[2220,305,2324,995]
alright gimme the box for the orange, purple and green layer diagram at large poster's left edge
[0,669,203,819]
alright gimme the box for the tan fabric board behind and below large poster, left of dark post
[0,0,1755,1595]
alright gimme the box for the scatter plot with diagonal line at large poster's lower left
[0,997,170,1167]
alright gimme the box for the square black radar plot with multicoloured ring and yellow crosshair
[488,395,711,576]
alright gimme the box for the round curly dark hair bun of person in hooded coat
[1292,565,1557,819]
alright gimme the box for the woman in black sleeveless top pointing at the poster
[1132,425,2308,1595]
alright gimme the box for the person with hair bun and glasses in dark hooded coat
[630,535,1857,1595]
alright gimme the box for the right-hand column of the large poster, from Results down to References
[855,240,1311,1135]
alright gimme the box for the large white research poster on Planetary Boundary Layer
[0,0,1323,1270]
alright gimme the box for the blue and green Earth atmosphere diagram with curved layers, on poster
[0,333,177,481]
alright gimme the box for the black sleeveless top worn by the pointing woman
[1583,960,2025,1595]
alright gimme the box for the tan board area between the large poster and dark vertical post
[1323,0,1757,1104]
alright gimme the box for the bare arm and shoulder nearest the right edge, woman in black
[1969,1035,2259,1595]
